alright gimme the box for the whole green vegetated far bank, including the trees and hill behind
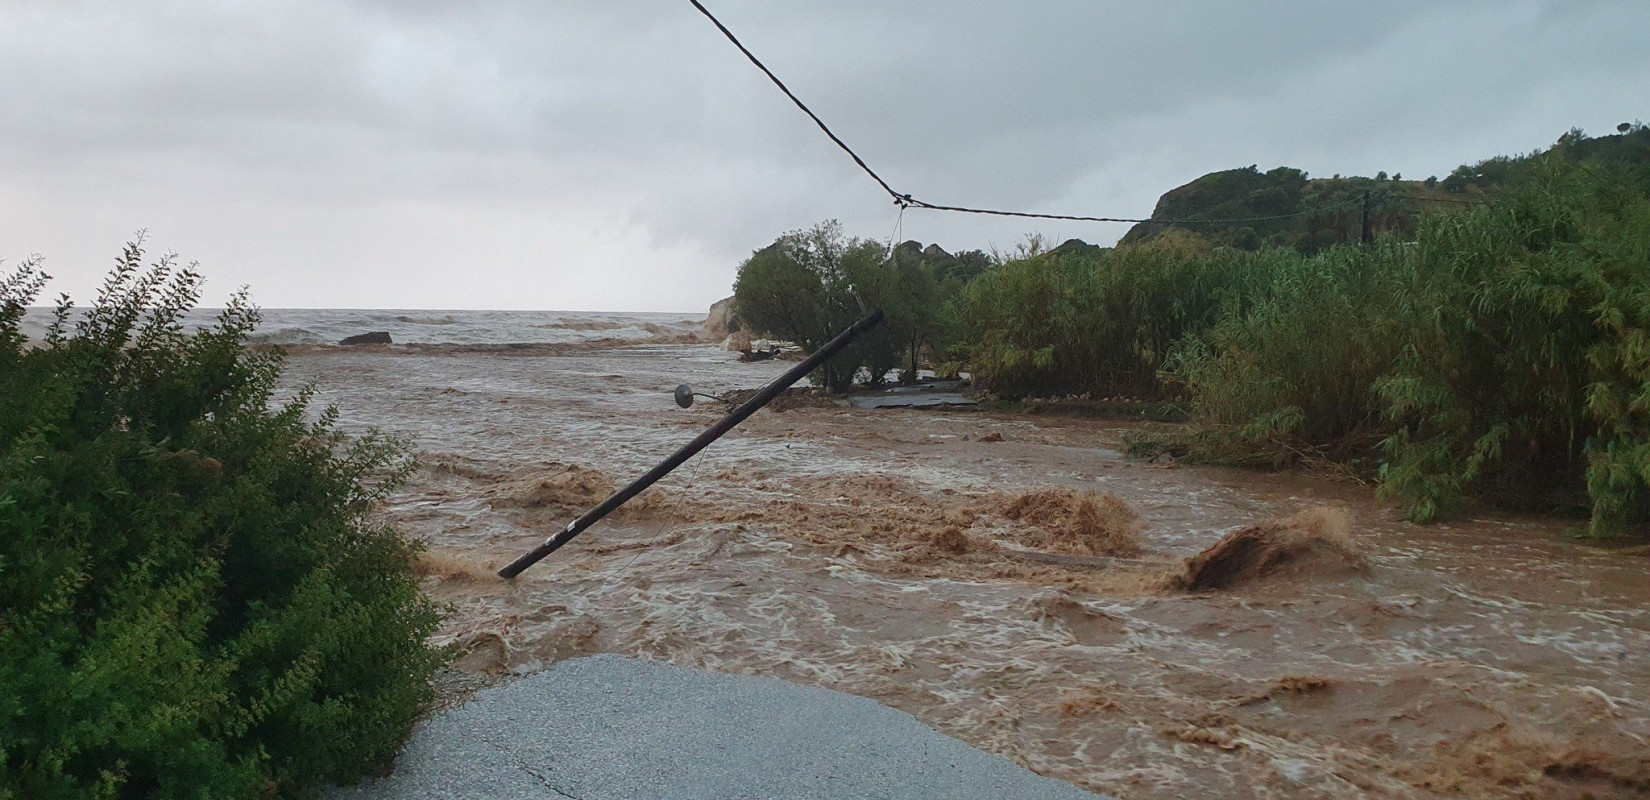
[736,124,1650,536]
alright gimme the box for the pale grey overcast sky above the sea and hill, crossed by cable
[0,0,1650,310]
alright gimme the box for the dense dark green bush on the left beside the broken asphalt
[0,244,439,800]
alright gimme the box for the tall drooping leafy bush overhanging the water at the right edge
[1374,163,1650,534]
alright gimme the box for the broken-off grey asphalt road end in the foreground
[332,655,1104,800]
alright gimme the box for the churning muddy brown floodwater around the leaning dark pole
[287,338,1650,798]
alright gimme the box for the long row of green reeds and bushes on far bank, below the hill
[955,146,1650,536]
